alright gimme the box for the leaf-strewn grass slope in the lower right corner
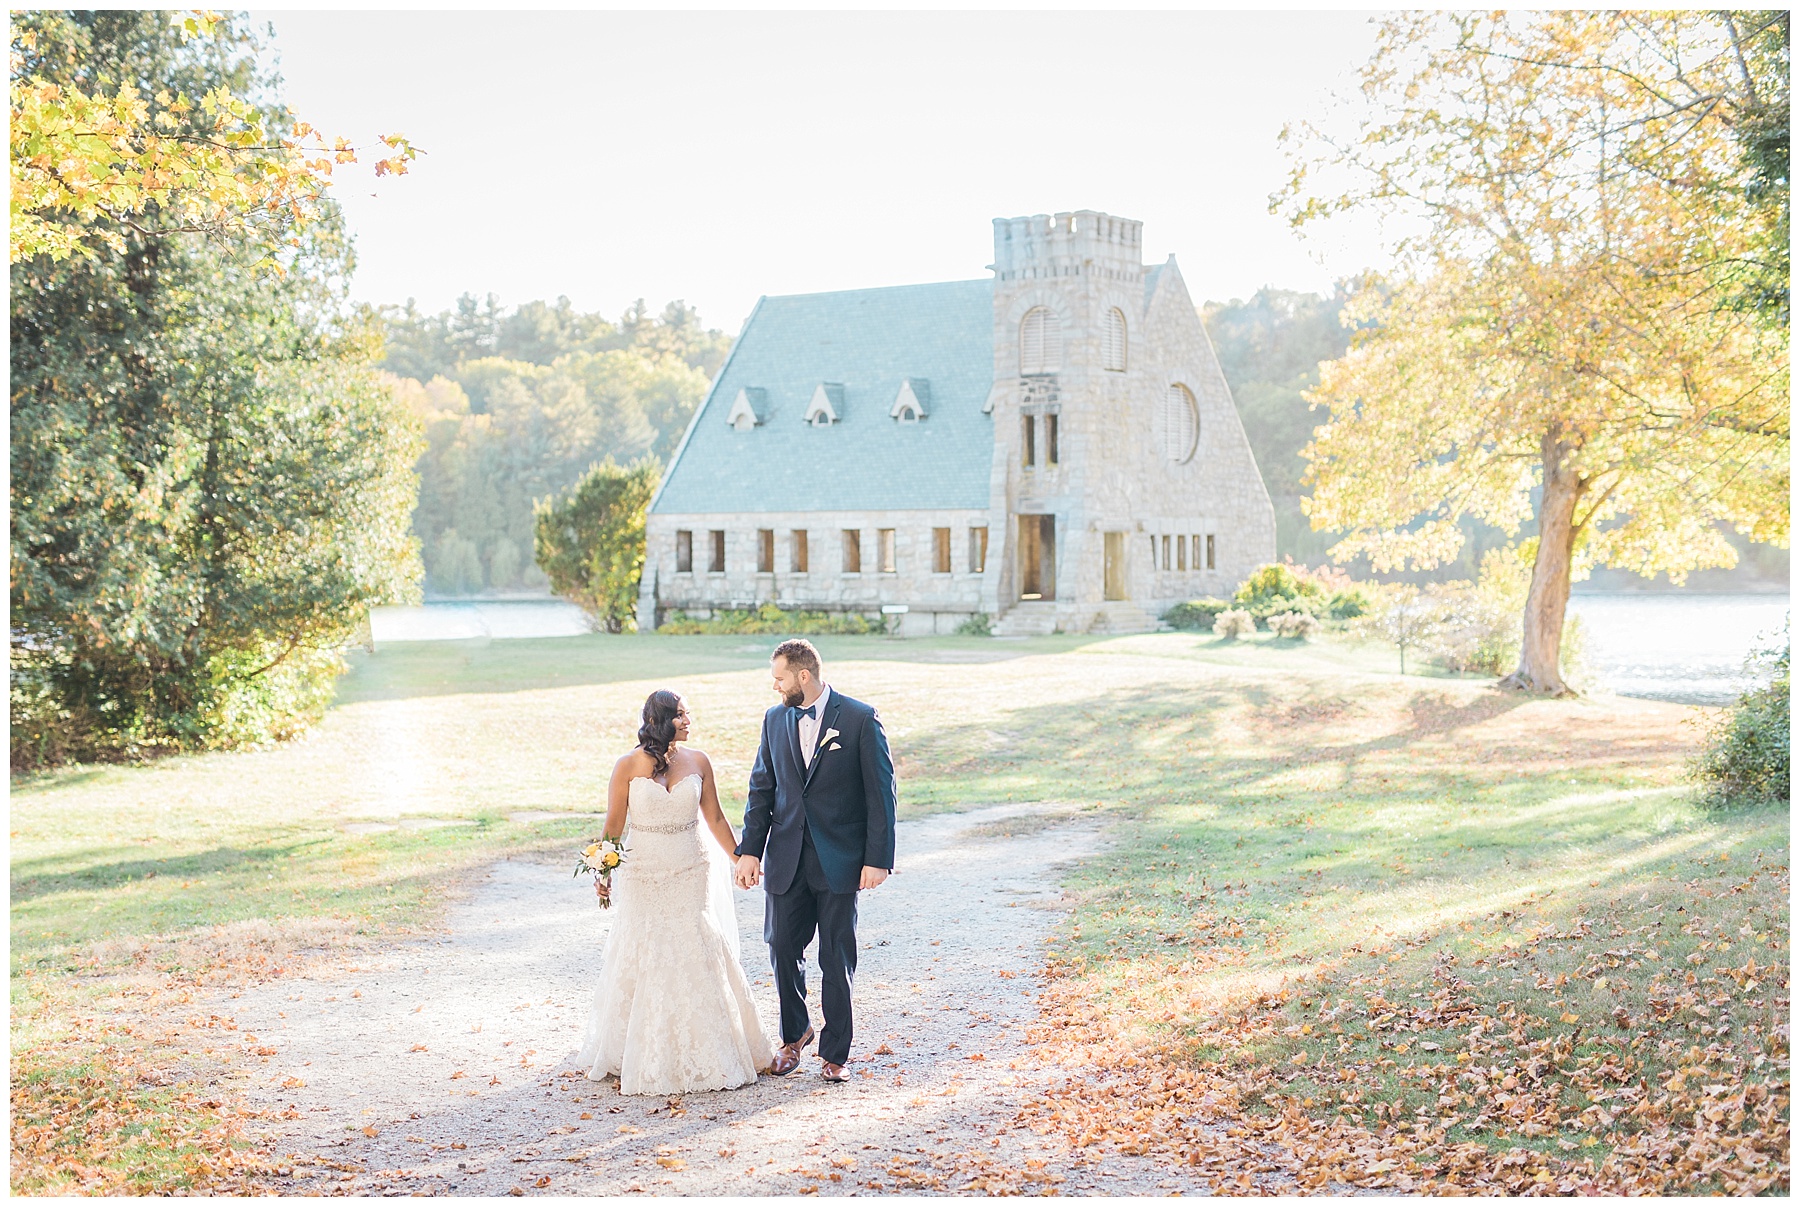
[1019,858,1791,1194]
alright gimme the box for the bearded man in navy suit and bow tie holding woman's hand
[738,640,895,1081]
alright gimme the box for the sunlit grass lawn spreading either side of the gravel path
[11,633,1787,1191]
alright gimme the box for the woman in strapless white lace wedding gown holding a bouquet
[576,691,772,1094]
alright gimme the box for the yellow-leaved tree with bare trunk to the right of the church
[1276,13,1787,693]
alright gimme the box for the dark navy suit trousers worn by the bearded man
[763,835,857,1065]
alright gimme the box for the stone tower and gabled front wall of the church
[988,210,1274,633]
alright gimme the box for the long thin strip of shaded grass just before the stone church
[333,633,1107,705]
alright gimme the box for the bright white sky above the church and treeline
[252,11,1377,333]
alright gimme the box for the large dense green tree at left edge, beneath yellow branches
[11,13,419,766]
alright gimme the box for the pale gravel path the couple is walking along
[220,806,1204,1194]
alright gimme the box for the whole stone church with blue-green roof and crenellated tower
[637,210,1274,635]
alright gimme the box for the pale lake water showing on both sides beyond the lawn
[373,592,1787,703]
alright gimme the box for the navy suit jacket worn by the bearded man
[738,687,896,892]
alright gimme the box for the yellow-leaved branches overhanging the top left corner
[7,11,418,266]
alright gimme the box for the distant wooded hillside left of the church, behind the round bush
[385,295,729,595]
